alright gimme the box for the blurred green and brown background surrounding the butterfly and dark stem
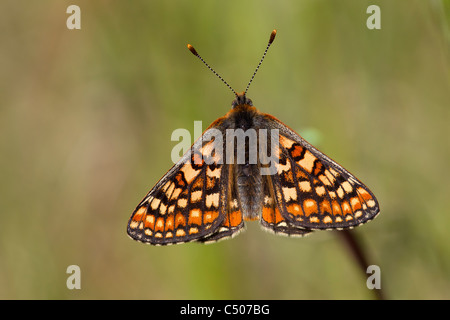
[0,0,450,299]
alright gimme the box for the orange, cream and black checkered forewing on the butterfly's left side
[127,128,234,245]
